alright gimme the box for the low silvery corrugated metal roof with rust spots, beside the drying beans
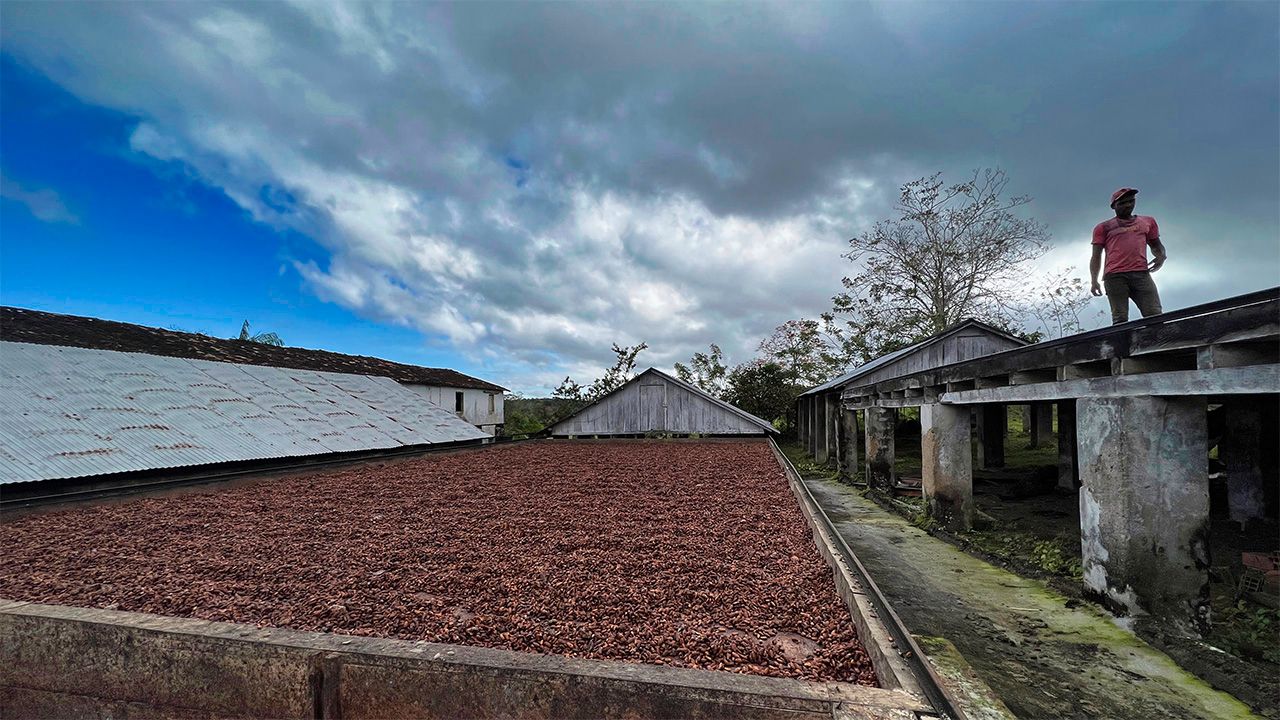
[0,342,488,484]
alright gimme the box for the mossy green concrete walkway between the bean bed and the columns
[805,479,1254,720]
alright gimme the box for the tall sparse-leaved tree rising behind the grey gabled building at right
[829,169,1048,361]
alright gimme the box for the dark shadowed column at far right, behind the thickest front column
[1217,397,1275,525]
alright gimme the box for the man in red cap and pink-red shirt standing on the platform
[1089,187,1166,325]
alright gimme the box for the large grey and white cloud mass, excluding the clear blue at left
[0,1,1280,388]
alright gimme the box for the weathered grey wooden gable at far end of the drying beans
[550,368,777,437]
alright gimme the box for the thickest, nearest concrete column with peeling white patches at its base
[1075,397,1210,632]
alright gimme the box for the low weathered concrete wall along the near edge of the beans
[0,601,928,719]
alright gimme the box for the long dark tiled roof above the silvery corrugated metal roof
[0,306,507,392]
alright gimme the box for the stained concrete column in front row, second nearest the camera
[920,404,973,530]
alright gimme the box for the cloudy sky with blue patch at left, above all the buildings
[0,1,1280,395]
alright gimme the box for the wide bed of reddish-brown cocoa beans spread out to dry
[0,441,876,684]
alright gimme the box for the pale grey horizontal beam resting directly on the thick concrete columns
[940,365,1280,405]
